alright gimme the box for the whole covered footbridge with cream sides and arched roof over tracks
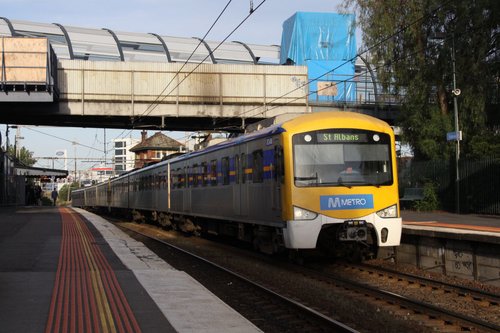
[0,17,398,131]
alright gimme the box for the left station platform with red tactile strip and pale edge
[0,207,260,332]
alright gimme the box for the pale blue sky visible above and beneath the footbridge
[0,0,352,171]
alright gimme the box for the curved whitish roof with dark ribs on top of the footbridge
[0,20,280,64]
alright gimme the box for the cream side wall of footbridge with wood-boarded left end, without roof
[0,37,308,130]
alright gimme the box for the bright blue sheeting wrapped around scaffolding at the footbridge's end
[280,12,356,102]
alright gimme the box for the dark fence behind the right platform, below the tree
[399,157,500,215]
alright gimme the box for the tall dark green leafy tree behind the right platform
[344,0,500,159]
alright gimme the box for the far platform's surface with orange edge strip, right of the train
[401,210,500,244]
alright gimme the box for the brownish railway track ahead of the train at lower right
[304,264,500,332]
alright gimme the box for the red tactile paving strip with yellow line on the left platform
[45,208,141,333]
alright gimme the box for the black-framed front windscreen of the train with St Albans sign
[292,129,393,187]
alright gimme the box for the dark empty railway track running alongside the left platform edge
[120,225,358,332]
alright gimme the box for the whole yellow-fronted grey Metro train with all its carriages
[71,111,402,258]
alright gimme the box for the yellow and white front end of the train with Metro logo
[282,112,401,257]
